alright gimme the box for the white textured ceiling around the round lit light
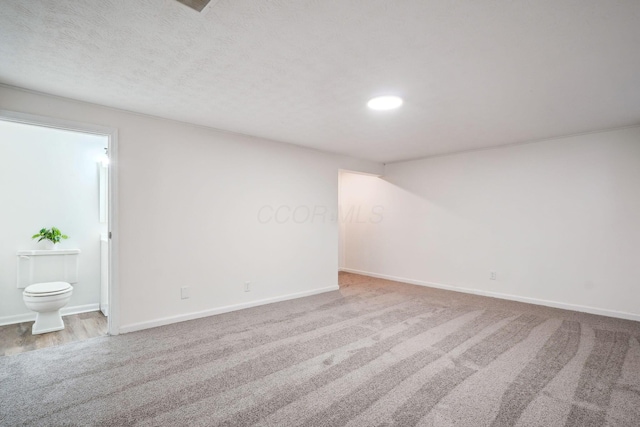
[0,0,640,162]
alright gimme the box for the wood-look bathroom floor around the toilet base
[0,311,107,356]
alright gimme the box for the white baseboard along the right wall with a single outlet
[340,268,640,321]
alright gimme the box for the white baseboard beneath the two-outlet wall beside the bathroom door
[119,285,340,334]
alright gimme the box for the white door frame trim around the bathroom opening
[0,110,120,335]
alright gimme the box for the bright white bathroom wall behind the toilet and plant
[0,120,107,324]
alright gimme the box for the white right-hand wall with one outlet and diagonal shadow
[341,128,640,320]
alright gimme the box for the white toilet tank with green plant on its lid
[18,249,80,289]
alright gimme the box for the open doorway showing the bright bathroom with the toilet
[0,111,118,356]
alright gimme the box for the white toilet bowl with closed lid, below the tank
[22,282,73,335]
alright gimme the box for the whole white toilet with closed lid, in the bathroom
[18,249,80,335]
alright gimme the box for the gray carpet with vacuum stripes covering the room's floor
[0,273,640,427]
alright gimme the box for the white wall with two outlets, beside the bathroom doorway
[0,86,382,331]
